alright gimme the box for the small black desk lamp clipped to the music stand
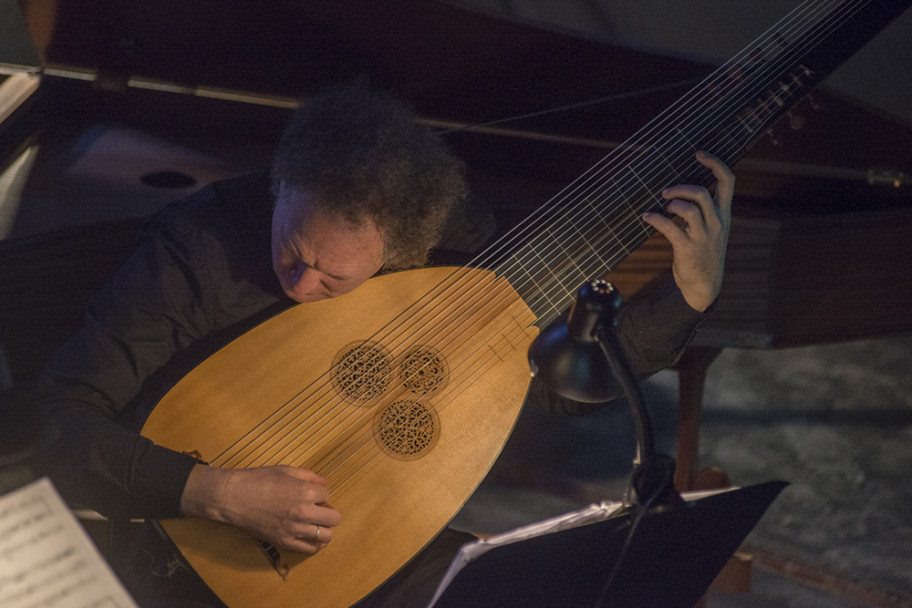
[529,280,681,505]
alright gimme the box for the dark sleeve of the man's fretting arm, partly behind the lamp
[529,277,712,415]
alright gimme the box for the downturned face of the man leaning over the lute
[272,184,383,302]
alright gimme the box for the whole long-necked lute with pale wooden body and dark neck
[143,0,909,608]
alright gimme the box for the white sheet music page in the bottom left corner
[0,478,138,608]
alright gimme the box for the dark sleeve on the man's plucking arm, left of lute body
[36,213,206,518]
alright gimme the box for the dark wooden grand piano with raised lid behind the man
[0,0,912,604]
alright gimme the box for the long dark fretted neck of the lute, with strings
[460,0,910,326]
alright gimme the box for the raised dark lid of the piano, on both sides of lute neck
[10,0,912,207]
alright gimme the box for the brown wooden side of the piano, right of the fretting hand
[696,206,912,348]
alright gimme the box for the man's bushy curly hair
[272,83,465,270]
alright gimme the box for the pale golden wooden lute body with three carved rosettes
[143,268,537,607]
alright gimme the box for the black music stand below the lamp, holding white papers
[433,481,787,608]
